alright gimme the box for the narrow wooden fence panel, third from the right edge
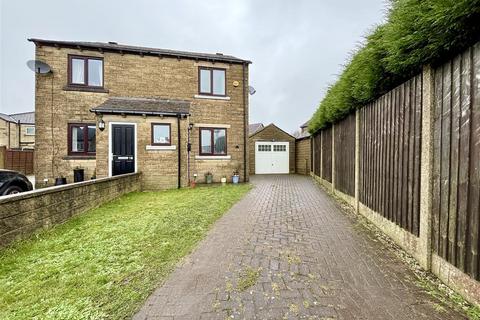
[334,113,355,197]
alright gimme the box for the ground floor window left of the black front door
[68,123,96,155]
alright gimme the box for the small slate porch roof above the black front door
[90,97,190,116]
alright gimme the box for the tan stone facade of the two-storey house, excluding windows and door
[31,44,248,189]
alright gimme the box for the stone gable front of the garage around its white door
[248,123,295,174]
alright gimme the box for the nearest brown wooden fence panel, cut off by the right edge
[432,43,480,280]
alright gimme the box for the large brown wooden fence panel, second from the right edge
[358,75,422,236]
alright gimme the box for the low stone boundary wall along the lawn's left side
[0,173,141,247]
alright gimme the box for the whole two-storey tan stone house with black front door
[29,39,251,189]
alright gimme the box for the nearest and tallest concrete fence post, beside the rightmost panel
[419,66,435,270]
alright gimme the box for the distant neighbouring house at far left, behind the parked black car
[0,112,35,149]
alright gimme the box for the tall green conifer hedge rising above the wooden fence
[309,0,480,133]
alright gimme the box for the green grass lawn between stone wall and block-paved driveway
[0,185,251,319]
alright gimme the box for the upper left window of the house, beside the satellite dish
[68,55,103,88]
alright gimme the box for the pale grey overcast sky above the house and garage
[0,0,385,132]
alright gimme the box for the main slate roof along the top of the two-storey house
[28,38,252,64]
